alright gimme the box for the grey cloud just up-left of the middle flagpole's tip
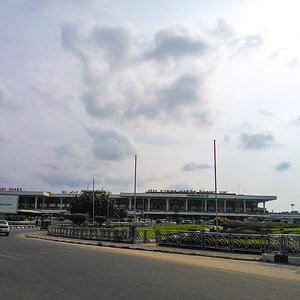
[86,127,136,161]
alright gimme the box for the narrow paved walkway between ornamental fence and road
[25,231,261,261]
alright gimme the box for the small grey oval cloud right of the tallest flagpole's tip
[239,133,274,150]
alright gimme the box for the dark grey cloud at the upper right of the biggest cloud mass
[145,27,209,61]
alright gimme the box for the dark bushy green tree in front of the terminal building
[70,191,127,219]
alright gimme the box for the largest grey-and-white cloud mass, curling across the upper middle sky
[61,24,211,125]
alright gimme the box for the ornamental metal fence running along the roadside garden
[48,226,300,255]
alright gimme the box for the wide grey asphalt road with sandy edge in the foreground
[0,231,300,300]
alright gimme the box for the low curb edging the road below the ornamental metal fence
[25,235,261,262]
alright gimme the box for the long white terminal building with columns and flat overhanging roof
[0,189,277,219]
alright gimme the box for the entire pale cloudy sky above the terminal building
[0,0,300,211]
